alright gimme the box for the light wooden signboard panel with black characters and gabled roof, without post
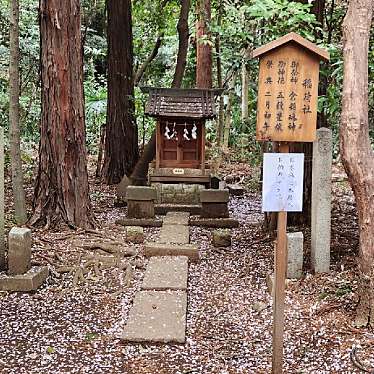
[252,33,329,142]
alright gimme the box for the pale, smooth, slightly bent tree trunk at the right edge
[340,0,374,327]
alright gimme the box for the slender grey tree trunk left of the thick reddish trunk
[9,0,27,225]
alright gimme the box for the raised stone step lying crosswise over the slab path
[145,242,199,261]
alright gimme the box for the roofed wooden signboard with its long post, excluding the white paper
[252,32,329,374]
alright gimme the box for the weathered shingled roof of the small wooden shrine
[141,87,223,119]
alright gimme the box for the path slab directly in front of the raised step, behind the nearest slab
[142,256,188,290]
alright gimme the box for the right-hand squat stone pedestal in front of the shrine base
[200,189,229,218]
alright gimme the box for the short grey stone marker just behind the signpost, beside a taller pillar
[287,232,304,279]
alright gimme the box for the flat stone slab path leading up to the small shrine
[121,212,194,343]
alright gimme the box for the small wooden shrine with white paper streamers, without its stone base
[142,87,221,184]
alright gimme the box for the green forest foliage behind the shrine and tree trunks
[0,0,374,172]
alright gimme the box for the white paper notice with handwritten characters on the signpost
[262,153,304,212]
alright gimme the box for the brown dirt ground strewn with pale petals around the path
[0,164,374,374]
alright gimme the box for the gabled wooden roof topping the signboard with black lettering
[252,32,330,61]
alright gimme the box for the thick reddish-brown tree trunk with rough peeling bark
[30,0,94,227]
